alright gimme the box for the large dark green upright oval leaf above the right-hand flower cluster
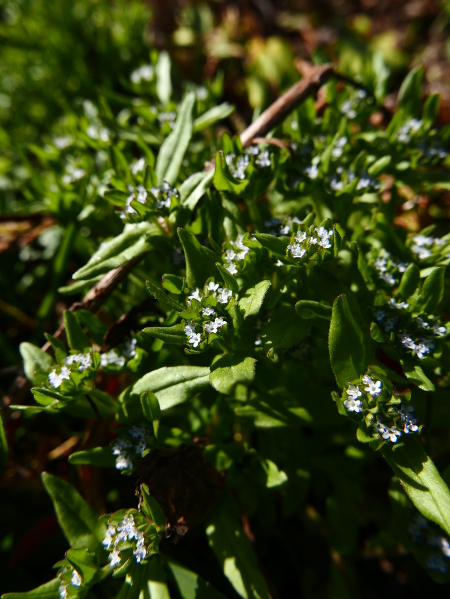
[329,295,368,388]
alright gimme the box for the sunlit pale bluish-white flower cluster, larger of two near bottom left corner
[103,514,147,568]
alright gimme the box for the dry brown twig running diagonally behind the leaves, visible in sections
[3,60,376,407]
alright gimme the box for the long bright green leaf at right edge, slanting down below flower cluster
[381,437,450,535]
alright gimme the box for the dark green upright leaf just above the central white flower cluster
[178,229,217,289]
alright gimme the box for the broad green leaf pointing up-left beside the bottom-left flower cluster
[42,472,106,552]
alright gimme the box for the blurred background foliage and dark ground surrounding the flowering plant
[0,0,450,598]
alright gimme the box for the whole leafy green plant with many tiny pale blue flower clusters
[2,53,450,599]
